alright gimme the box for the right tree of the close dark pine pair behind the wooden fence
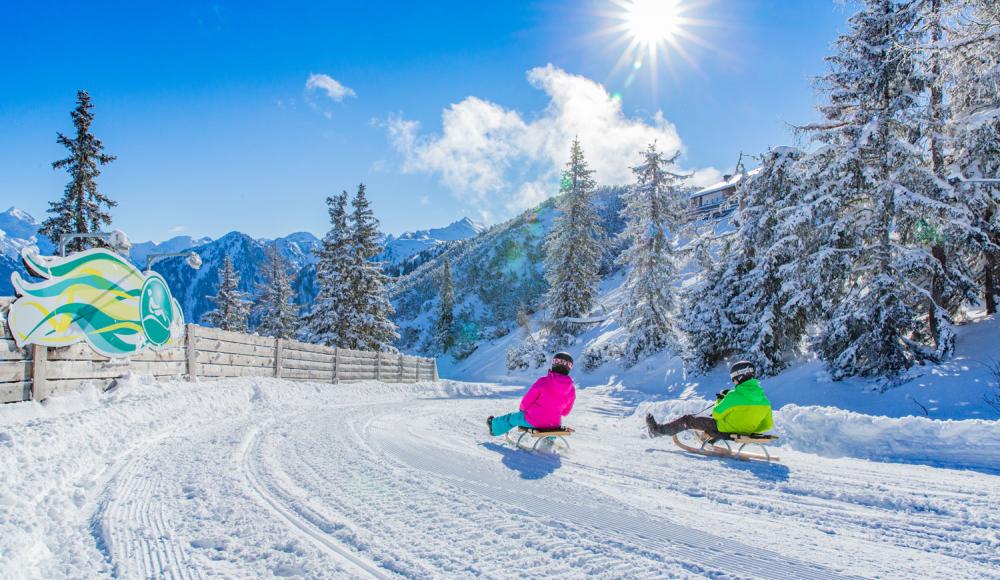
[342,183,399,351]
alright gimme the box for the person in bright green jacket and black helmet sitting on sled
[646,361,774,438]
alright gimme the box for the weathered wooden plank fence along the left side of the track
[0,298,438,403]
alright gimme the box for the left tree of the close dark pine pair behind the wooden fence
[302,191,354,347]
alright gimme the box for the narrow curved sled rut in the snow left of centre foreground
[242,427,390,578]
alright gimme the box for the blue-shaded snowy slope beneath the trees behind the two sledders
[439,274,1000,419]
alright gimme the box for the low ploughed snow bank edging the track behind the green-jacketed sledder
[636,399,1000,473]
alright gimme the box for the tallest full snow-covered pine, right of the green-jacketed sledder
[805,0,953,379]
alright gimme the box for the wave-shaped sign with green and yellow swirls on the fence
[7,249,184,357]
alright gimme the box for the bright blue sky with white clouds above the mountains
[0,0,849,240]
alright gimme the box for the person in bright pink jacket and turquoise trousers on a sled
[486,352,576,437]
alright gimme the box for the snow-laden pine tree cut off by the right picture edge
[946,0,1000,314]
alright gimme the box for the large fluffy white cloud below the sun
[386,64,718,214]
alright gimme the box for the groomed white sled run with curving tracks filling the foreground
[0,379,1000,579]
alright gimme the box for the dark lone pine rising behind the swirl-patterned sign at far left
[39,91,118,252]
